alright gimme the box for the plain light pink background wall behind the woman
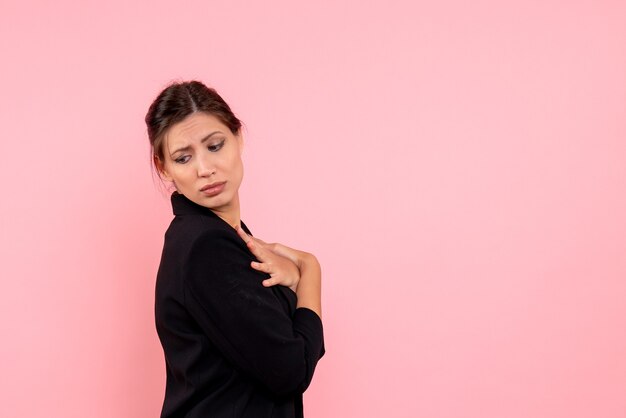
[0,0,626,418]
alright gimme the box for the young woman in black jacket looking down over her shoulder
[146,81,324,418]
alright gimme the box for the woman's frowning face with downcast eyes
[161,112,243,220]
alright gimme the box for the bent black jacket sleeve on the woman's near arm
[183,229,324,396]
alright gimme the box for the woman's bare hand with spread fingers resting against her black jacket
[236,226,300,292]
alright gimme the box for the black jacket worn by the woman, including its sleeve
[155,192,324,418]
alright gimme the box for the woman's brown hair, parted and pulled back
[146,80,241,173]
